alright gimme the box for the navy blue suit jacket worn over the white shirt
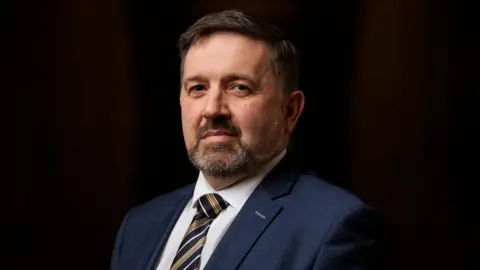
[111,159,381,270]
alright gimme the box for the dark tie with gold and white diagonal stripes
[170,193,228,270]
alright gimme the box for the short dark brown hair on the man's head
[178,10,299,93]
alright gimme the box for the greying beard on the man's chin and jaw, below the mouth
[188,137,278,177]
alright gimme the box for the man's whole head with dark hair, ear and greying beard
[178,11,304,177]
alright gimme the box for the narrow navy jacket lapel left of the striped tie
[136,186,193,270]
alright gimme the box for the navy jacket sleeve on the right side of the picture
[313,206,387,270]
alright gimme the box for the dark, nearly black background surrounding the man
[4,0,480,270]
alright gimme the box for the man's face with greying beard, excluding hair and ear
[180,32,287,177]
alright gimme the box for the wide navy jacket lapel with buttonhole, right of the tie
[205,156,298,270]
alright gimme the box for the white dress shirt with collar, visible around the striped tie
[157,150,286,270]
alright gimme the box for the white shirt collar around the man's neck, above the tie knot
[191,149,287,210]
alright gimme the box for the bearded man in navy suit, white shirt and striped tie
[112,11,379,270]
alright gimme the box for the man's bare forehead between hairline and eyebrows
[183,32,270,76]
